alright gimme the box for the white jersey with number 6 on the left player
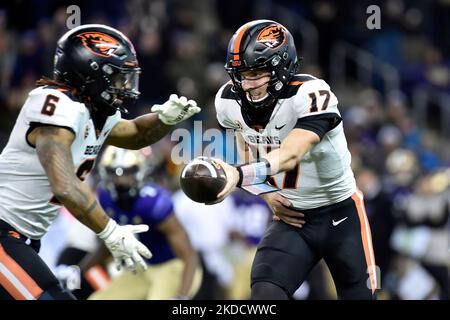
[0,87,121,239]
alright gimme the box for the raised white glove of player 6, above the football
[152,94,201,126]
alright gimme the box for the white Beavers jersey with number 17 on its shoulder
[215,74,356,209]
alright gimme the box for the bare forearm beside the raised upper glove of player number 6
[133,113,172,149]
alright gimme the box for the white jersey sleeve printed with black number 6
[25,88,81,135]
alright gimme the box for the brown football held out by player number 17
[180,157,227,203]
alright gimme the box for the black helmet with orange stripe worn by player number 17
[225,20,298,108]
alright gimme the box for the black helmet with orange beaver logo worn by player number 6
[54,24,141,115]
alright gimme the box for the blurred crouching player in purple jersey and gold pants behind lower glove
[71,147,202,300]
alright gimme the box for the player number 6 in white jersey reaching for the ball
[0,24,200,299]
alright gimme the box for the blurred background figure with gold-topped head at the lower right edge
[391,170,450,300]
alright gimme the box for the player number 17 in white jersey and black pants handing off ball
[215,20,378,299]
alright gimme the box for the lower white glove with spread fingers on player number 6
[97,219,152,272]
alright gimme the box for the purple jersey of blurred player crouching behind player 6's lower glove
[98,184,175,264]
